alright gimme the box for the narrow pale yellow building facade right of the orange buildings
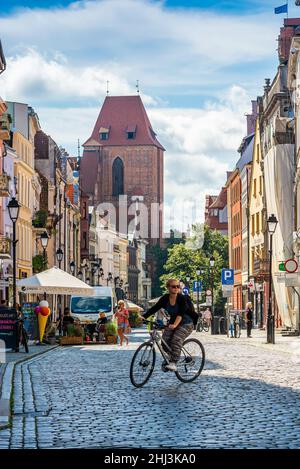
[249,119,268,327]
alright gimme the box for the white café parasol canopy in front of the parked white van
[17,267,93,295]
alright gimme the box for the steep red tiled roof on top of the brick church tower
[84,96,164,150]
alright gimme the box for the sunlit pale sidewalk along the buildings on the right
[209,329,300,360]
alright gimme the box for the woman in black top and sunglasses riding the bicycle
[143,278,198,371]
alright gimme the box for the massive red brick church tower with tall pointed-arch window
[80,95,164,243]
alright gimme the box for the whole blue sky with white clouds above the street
[0,0,300,227]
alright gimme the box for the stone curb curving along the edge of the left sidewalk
[0,345,59,430]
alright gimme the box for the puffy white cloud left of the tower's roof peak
[1,49,155,104]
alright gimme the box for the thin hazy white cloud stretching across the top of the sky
[0,0,277,94]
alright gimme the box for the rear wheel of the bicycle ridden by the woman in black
[175,339,205,383]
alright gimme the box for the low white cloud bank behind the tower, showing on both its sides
[39,86,250,229]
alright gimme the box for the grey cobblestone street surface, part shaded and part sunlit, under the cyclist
[0,330,300,448]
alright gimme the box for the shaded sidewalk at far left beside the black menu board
[0,345,58,429]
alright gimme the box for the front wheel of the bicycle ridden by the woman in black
[130,342,156,388]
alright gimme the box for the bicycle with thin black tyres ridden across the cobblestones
[130,319,205,388]
